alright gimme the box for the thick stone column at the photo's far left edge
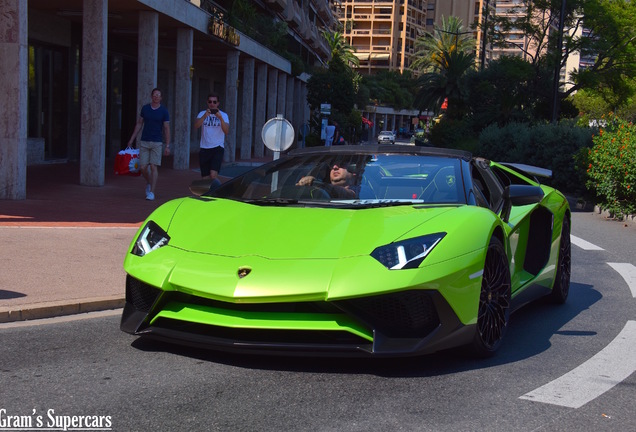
[0,0,29,200]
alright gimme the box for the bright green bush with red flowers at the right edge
[587,116,636,218]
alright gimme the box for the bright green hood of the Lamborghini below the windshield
[164,198,455,259]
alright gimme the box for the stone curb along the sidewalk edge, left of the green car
[0,296,126,323]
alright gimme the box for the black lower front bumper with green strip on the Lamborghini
[121,276,474,356]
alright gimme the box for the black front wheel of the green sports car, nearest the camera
[471,237,511,357]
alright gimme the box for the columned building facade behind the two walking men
[0,0,335,199]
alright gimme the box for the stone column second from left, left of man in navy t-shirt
[80,0,108,186]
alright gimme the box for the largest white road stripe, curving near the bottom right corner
[519,321,636,408]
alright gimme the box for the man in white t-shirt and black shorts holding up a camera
[194,93,230,184]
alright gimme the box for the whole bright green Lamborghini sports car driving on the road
[121,145,570,356]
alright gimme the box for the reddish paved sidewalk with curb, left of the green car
[0,155,266,323]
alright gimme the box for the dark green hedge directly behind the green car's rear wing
[478,120,592,196]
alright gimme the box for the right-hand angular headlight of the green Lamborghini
[371,233,446,270]
